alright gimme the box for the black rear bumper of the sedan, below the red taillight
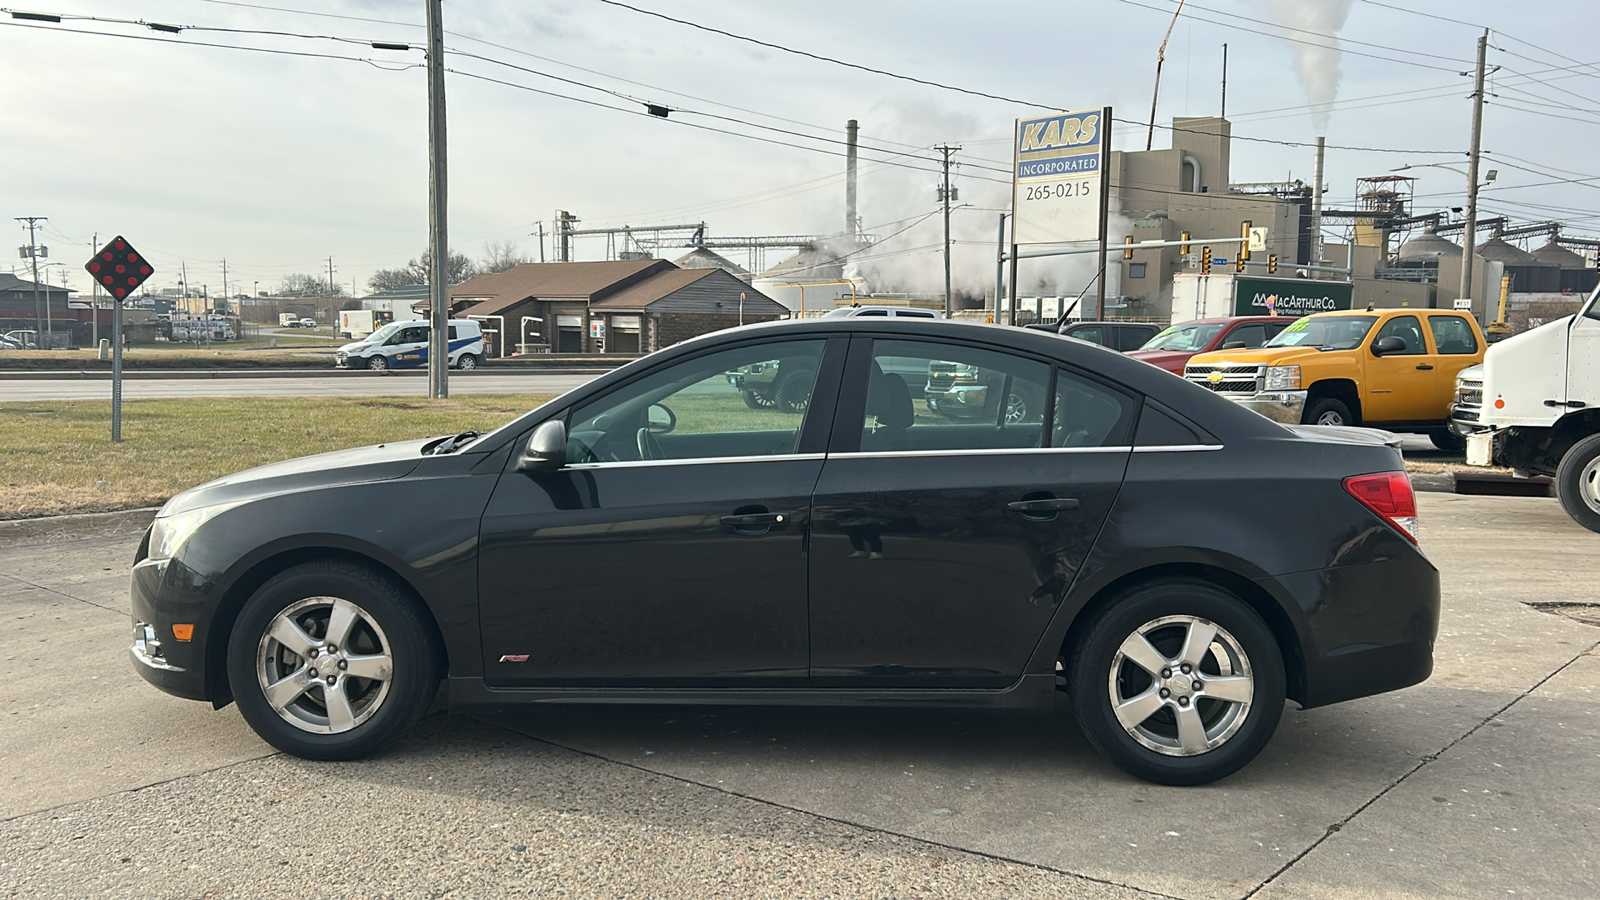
[1278,551,1440,708]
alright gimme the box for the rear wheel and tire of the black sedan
[1064,580,1285,786]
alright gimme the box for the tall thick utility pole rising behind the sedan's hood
[427,0,450,400]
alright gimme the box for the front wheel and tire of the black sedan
[227,560,442,759]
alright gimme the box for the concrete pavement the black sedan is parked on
[0,493,1600,900]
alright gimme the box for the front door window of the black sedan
[566,341,822,463]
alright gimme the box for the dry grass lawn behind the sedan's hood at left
[0,394,550,519]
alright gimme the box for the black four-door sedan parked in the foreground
[131,317,1438,785]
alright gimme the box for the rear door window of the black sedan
[861,341,1050,452]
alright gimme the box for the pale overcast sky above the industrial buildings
[0,0,1600,295]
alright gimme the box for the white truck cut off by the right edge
[1451,288,1600,532]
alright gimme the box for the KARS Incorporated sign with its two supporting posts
[1011,106,1112,323]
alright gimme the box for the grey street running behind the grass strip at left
[0,372,600,402]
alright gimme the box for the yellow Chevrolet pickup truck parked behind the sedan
[1184,309,1485,450]
